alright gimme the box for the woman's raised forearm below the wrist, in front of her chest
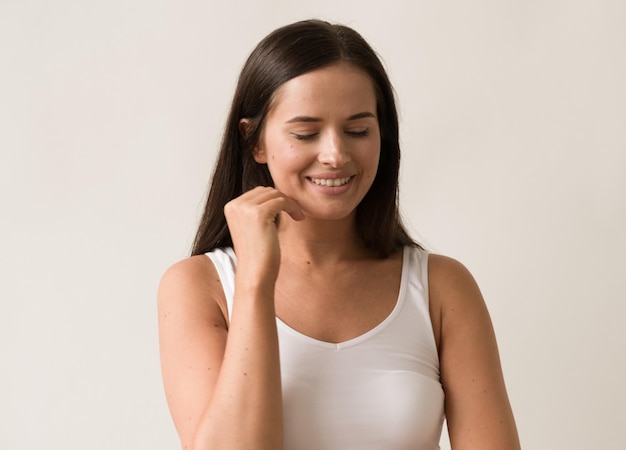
[194,286,282,450]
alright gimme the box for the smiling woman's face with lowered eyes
[255,64,380,220]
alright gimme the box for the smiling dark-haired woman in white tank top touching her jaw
[159,21,519,450]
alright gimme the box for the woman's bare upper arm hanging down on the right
[429,255,519,450]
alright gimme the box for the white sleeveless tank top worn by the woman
[207,247,444,450]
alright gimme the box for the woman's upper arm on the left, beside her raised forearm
[158,255,227,446]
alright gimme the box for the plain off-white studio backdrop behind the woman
[0,0,626,450]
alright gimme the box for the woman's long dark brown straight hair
[192,20,417,257]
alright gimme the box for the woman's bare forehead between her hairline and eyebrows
[270,63,376,117]
